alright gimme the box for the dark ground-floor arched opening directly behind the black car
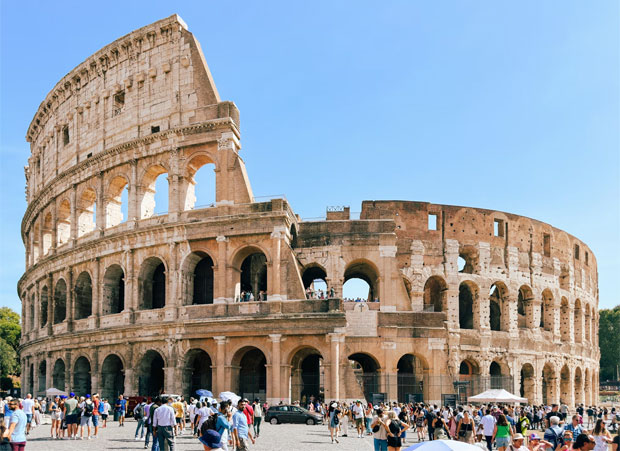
[291,348,325,407]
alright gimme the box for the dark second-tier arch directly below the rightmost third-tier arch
[182,250,215,305]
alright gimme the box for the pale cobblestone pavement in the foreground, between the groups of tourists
[21,420,386,451]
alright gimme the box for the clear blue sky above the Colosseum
[0,0,620,311]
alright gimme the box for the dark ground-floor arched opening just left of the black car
[233,346,267,399]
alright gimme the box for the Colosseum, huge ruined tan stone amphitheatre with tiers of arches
[18,15,599,405]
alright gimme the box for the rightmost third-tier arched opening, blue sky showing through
[184,155,216,210]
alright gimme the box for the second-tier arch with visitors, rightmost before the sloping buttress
[232,245,271,300]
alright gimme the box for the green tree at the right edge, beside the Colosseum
[598,305,620,381]
